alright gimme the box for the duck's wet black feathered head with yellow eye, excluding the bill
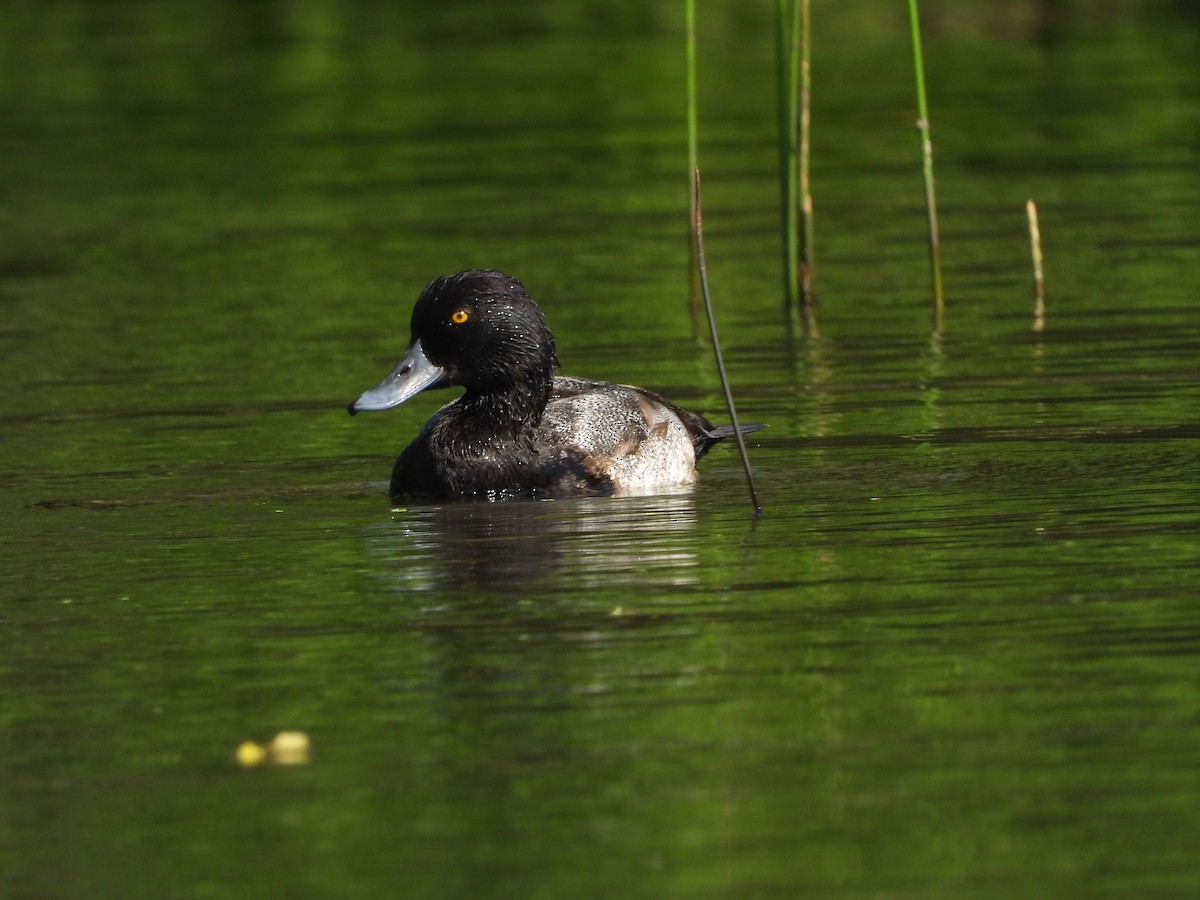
[412,269,558,394]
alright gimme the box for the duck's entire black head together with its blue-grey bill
[349,269,558,415]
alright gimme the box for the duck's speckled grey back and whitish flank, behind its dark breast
[538,376,712,494]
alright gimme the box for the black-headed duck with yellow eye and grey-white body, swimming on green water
[348,269,762,500]
